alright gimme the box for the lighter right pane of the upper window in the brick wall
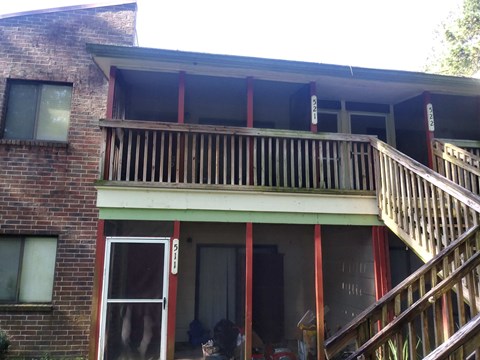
[37,85,72,141]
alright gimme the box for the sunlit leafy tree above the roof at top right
[426,0,480,76]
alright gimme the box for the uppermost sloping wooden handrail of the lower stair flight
[325,225,479,358]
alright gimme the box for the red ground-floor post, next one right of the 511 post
[245,223,253,359]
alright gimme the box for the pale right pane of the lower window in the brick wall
[19,237,57,302]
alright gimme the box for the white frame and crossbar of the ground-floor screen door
[97,236,170,360]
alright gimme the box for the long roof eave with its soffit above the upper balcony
[87,44,480,104]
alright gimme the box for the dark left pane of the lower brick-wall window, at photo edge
[0,238,22,301]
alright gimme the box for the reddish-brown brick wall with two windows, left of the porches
[0,4,136,358]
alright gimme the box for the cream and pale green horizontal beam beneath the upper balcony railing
[97,185,381,225]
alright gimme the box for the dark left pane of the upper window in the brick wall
[4,84,37,139]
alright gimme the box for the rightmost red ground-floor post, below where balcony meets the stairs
[372,226,392,300]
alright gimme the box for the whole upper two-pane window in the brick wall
[3,80,72,142]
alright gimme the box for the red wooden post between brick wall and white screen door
[89,220,105,359]
